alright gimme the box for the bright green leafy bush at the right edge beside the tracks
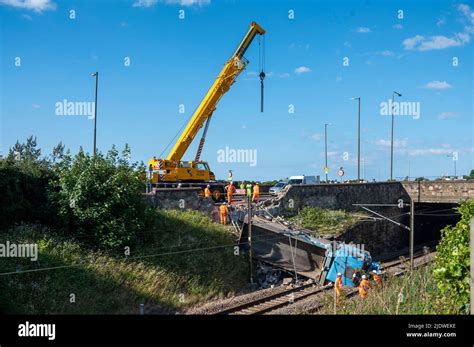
[433,199,474,313]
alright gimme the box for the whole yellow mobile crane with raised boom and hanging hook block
[148,22,265,200]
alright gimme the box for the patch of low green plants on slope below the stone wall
[291,207,365,236]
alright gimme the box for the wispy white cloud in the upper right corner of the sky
[402,4,474,52]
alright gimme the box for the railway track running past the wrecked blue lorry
[215,252,435,315]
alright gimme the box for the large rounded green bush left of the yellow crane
[49,146,151,249]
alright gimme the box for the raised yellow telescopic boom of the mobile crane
[166,22,265,162]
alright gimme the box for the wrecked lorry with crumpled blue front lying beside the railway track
[239,217,379,286]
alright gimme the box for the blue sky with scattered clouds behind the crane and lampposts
[0,0,474,180]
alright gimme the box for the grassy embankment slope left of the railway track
[0,211,248,314]
